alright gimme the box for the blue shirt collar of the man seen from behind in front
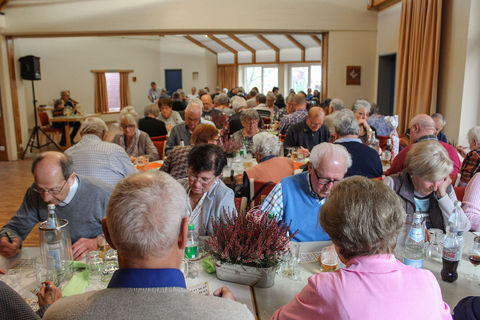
[108,268,187,288]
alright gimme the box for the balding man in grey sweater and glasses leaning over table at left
[0,151,112,259]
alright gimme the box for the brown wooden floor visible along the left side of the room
[0,123,121,247]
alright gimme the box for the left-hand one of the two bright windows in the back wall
[240,66,278,93]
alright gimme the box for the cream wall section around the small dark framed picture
[328,31,377,106]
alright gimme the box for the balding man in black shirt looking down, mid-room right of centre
[284,107,330,156]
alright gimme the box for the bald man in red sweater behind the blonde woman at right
[385,114,460,176]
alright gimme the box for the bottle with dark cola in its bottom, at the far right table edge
[440,201,463,282]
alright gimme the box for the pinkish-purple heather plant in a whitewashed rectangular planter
[206,208,295,288]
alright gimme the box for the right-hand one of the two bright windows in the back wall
[290,65,322,92]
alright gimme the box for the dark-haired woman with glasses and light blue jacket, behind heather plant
[179,144,237,236]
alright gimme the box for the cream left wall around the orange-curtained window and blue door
[15,37,217,141]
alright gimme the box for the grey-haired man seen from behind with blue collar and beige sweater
[44,172,253,319]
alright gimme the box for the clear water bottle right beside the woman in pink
[403,212,425,268]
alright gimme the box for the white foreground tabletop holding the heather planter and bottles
[0,232,480,319]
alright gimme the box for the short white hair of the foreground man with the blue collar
[107,171,188,258]
